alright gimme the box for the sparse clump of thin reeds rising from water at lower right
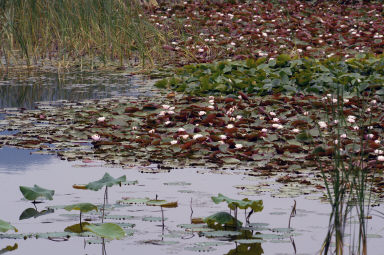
[318,86,375,255]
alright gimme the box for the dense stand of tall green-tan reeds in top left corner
[0,0,164,68]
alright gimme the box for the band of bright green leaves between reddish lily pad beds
[155,54,384,95]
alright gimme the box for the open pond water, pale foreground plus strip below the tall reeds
[0,74,384,255]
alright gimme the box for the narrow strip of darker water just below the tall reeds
[0,72,155,109]
